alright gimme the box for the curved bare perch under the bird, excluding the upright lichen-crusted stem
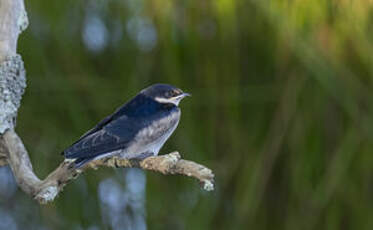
[0,130,214,204]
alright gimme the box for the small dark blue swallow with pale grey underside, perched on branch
[62,83,191,168]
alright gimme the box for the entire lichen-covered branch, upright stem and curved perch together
[0,0,214,203]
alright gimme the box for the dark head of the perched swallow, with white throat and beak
[141,84,191,106]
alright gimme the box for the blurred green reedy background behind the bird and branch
[0,0,373,230]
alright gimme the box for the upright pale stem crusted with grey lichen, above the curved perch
[0,0,28,134]
